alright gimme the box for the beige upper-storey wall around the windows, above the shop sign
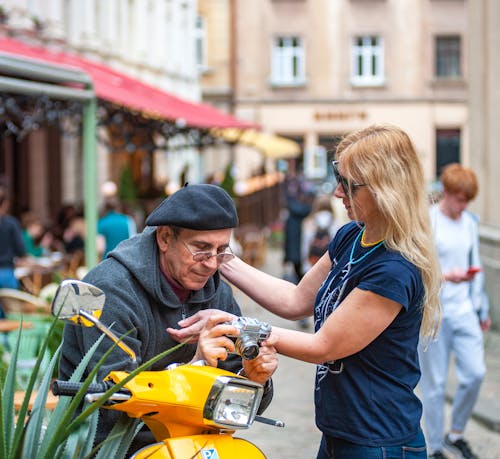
[236,0,467,101]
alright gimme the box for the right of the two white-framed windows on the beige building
[351,36,384,86]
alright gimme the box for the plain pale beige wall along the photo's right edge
[469,0,500,330]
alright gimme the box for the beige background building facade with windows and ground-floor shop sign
[230,0,471,183]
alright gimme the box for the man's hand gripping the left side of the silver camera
[192,309,238,367]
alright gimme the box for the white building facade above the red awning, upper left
[1,0,200,101]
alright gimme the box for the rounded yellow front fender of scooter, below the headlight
[131,434,266,459]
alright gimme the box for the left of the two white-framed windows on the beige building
[271,37,305,86]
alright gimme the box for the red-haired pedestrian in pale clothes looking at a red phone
[419,163,490,459]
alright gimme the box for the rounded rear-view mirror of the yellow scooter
[51,279,106,325]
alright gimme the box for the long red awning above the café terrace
[0,38,256,129]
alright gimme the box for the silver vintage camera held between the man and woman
[227,317,271,360]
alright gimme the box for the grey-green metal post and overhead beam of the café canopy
[0,52,98,269]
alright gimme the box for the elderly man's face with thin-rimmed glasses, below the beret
[156,226,231,290]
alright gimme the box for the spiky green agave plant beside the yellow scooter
[0,319,183,459]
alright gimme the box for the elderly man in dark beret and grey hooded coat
[59,184,277,450]
